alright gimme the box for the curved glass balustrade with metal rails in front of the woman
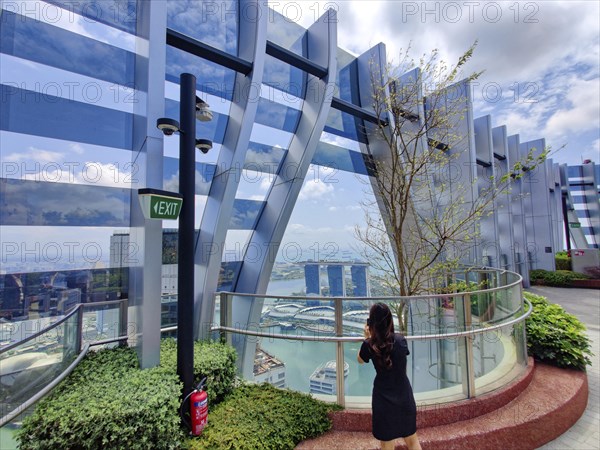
[212,269,531,407]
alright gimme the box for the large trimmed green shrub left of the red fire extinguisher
[17,348,185,450]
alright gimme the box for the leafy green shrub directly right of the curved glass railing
[525,292,592,370]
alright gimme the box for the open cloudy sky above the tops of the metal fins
[269,0,600,164]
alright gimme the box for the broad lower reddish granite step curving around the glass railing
[296,364,588,450]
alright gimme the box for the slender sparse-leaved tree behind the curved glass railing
[355,43,548,329]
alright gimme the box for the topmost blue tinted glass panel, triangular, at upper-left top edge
[45,0,138,34]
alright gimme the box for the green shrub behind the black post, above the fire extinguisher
[160,339,237,409]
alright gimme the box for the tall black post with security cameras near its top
[156,73,212,397]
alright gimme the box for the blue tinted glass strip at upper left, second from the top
[0,10,135,86]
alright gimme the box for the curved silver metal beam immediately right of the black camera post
[194,0,269,339]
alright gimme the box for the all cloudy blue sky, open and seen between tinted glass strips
[0,0,600,265]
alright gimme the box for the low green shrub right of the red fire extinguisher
[189,384,336,450]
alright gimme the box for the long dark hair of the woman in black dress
[368,303,394,369]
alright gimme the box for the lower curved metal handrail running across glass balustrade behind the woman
[210,297,533,342]
